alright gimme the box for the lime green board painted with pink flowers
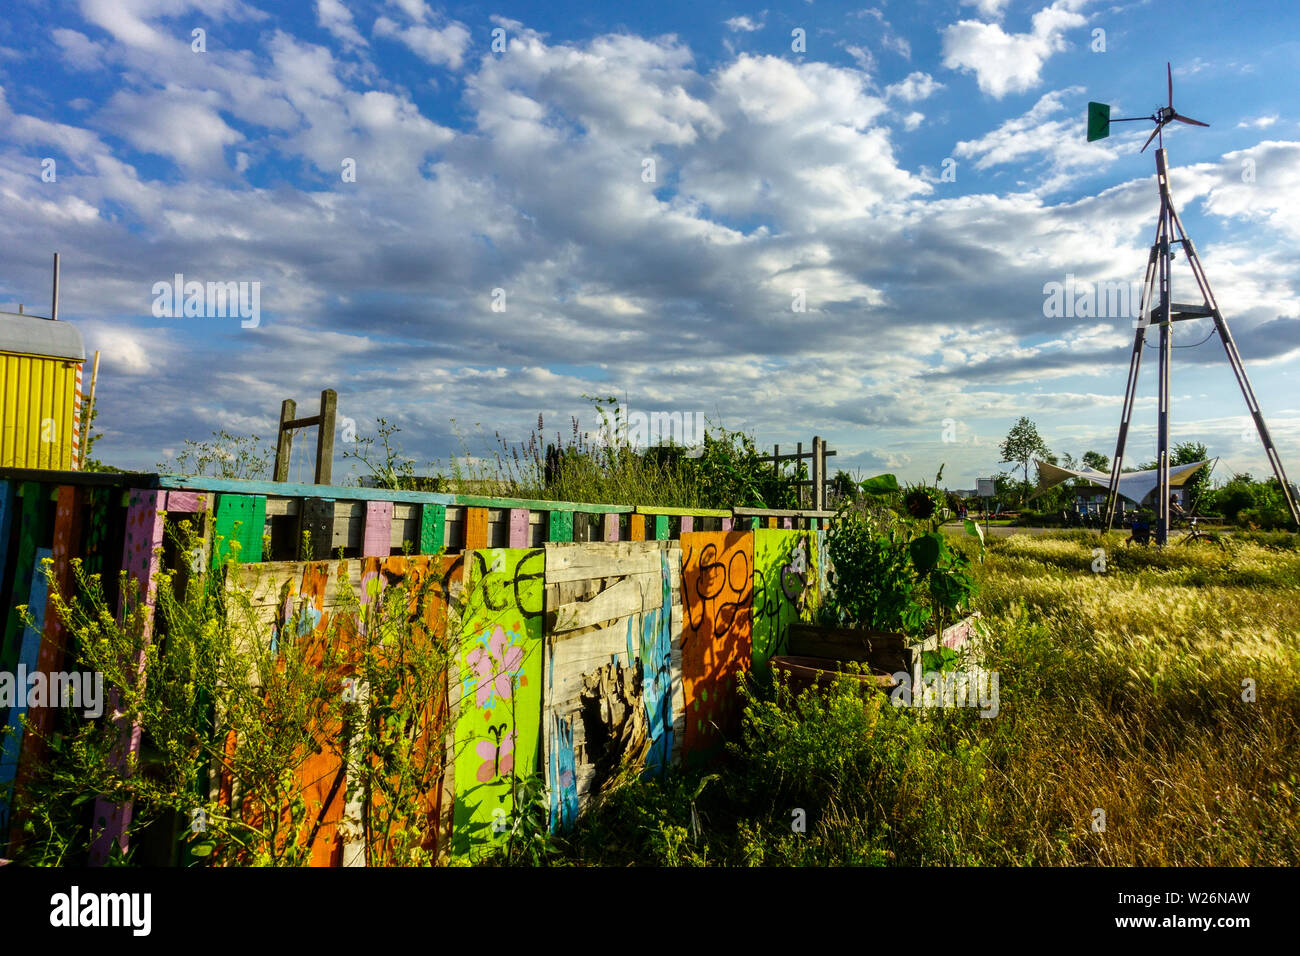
[451,548,545,858]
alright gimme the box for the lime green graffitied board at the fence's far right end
[754,528,813,675]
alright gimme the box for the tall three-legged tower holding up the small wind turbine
[1105,146,1300,544]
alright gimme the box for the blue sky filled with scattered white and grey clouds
[0,0,1300,486]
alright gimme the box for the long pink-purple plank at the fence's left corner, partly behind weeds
[90,488,166,866]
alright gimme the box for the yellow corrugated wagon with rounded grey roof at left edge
[0,313,85,470]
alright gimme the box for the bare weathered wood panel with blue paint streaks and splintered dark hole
[543,541,685,829]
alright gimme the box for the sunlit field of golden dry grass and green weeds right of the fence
[553,532,1300,866]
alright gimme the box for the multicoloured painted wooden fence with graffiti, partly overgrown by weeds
[0,470,829,866]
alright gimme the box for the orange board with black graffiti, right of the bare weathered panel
[681,531,754,762]
